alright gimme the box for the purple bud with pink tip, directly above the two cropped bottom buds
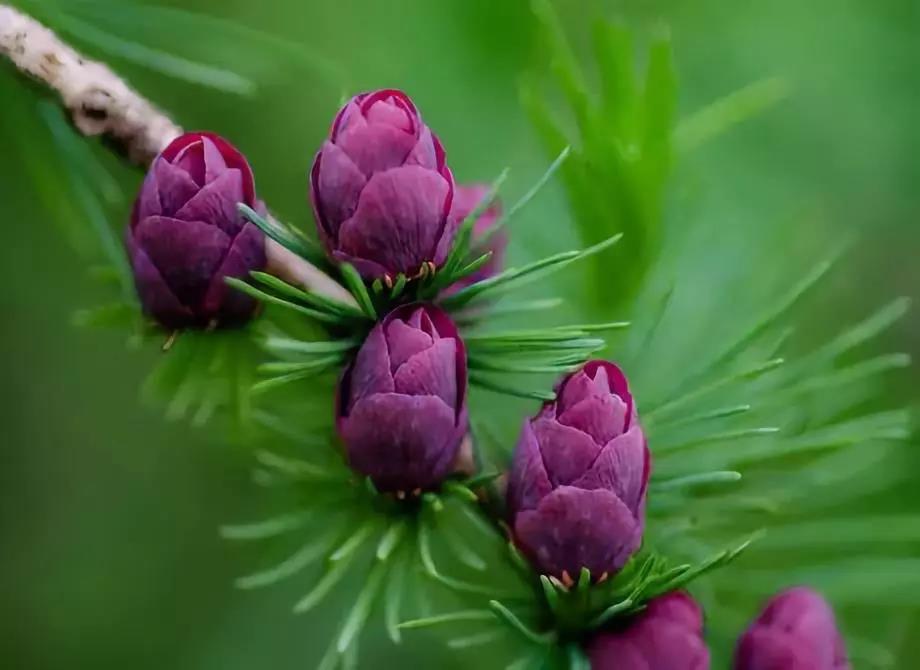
[508,361,651,582]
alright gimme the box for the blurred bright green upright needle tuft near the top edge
[521,1,676,309]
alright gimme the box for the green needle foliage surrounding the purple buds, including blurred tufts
[10,1,920,668]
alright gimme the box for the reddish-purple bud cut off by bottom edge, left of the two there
[588,592,709,670]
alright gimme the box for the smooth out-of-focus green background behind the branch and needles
[0,0,920,670]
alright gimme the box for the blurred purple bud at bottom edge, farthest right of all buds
[734,587,851,670]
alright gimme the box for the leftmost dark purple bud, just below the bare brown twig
[125,133,265,328]
